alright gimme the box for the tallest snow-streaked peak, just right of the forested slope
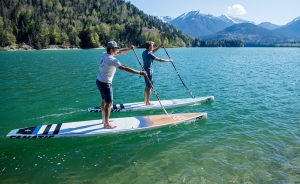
[169,10,230,37]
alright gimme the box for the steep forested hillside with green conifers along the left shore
[0,0,199,49]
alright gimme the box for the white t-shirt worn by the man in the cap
[97,52,122,84]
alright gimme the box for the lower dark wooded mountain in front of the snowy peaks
[201,23,295,43]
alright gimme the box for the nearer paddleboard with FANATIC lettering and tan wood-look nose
[6,112,207,139]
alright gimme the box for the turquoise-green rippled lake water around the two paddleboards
[0,48,300,184]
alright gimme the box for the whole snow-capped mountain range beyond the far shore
[161,10,300,42]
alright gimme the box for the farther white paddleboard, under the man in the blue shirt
[88,96,214,112]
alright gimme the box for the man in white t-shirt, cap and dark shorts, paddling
[96,41,147,129]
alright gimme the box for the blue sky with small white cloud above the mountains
[126,0,300,25]
